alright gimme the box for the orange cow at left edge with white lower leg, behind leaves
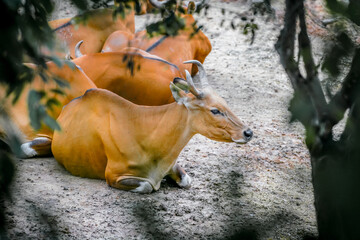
[0,62,96,157]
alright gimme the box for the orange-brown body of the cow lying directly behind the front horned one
[73,48,182,106]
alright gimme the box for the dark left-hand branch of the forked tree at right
[275,0,332,151]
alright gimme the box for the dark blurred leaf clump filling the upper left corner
[0,0,54,97]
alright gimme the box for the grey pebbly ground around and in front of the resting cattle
[6,1,317,239]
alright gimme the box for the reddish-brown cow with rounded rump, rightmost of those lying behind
[100,0,211,75]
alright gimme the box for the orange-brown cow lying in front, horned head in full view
[52,61,252,193]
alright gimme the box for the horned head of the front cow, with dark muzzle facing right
[170,60,253,144]
